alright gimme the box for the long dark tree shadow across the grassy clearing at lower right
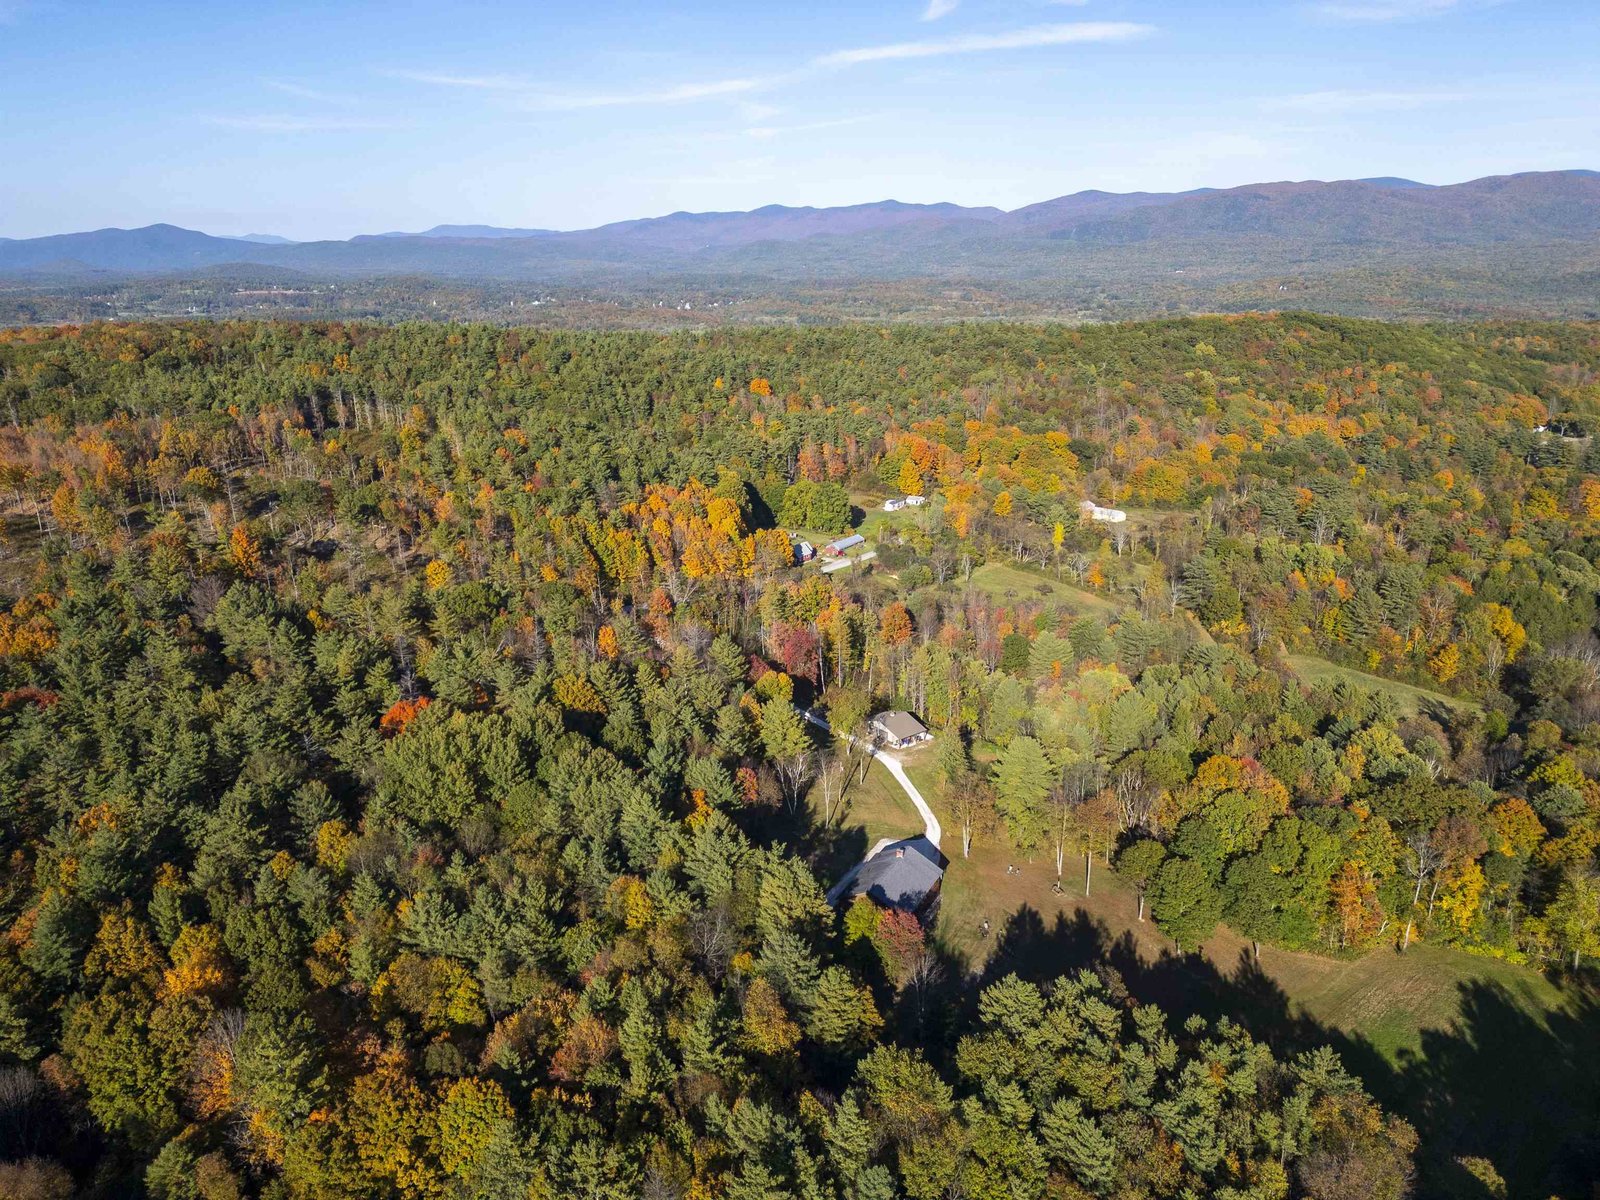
[978,906,1600,1200]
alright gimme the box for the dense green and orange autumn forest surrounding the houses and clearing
[0,314,1600,1200]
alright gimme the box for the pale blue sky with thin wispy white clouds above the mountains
[0,0,1600,240]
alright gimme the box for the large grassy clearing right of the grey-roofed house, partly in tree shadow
[912,771,1600,1200]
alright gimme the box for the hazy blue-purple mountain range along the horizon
[0,171,1600,305]
